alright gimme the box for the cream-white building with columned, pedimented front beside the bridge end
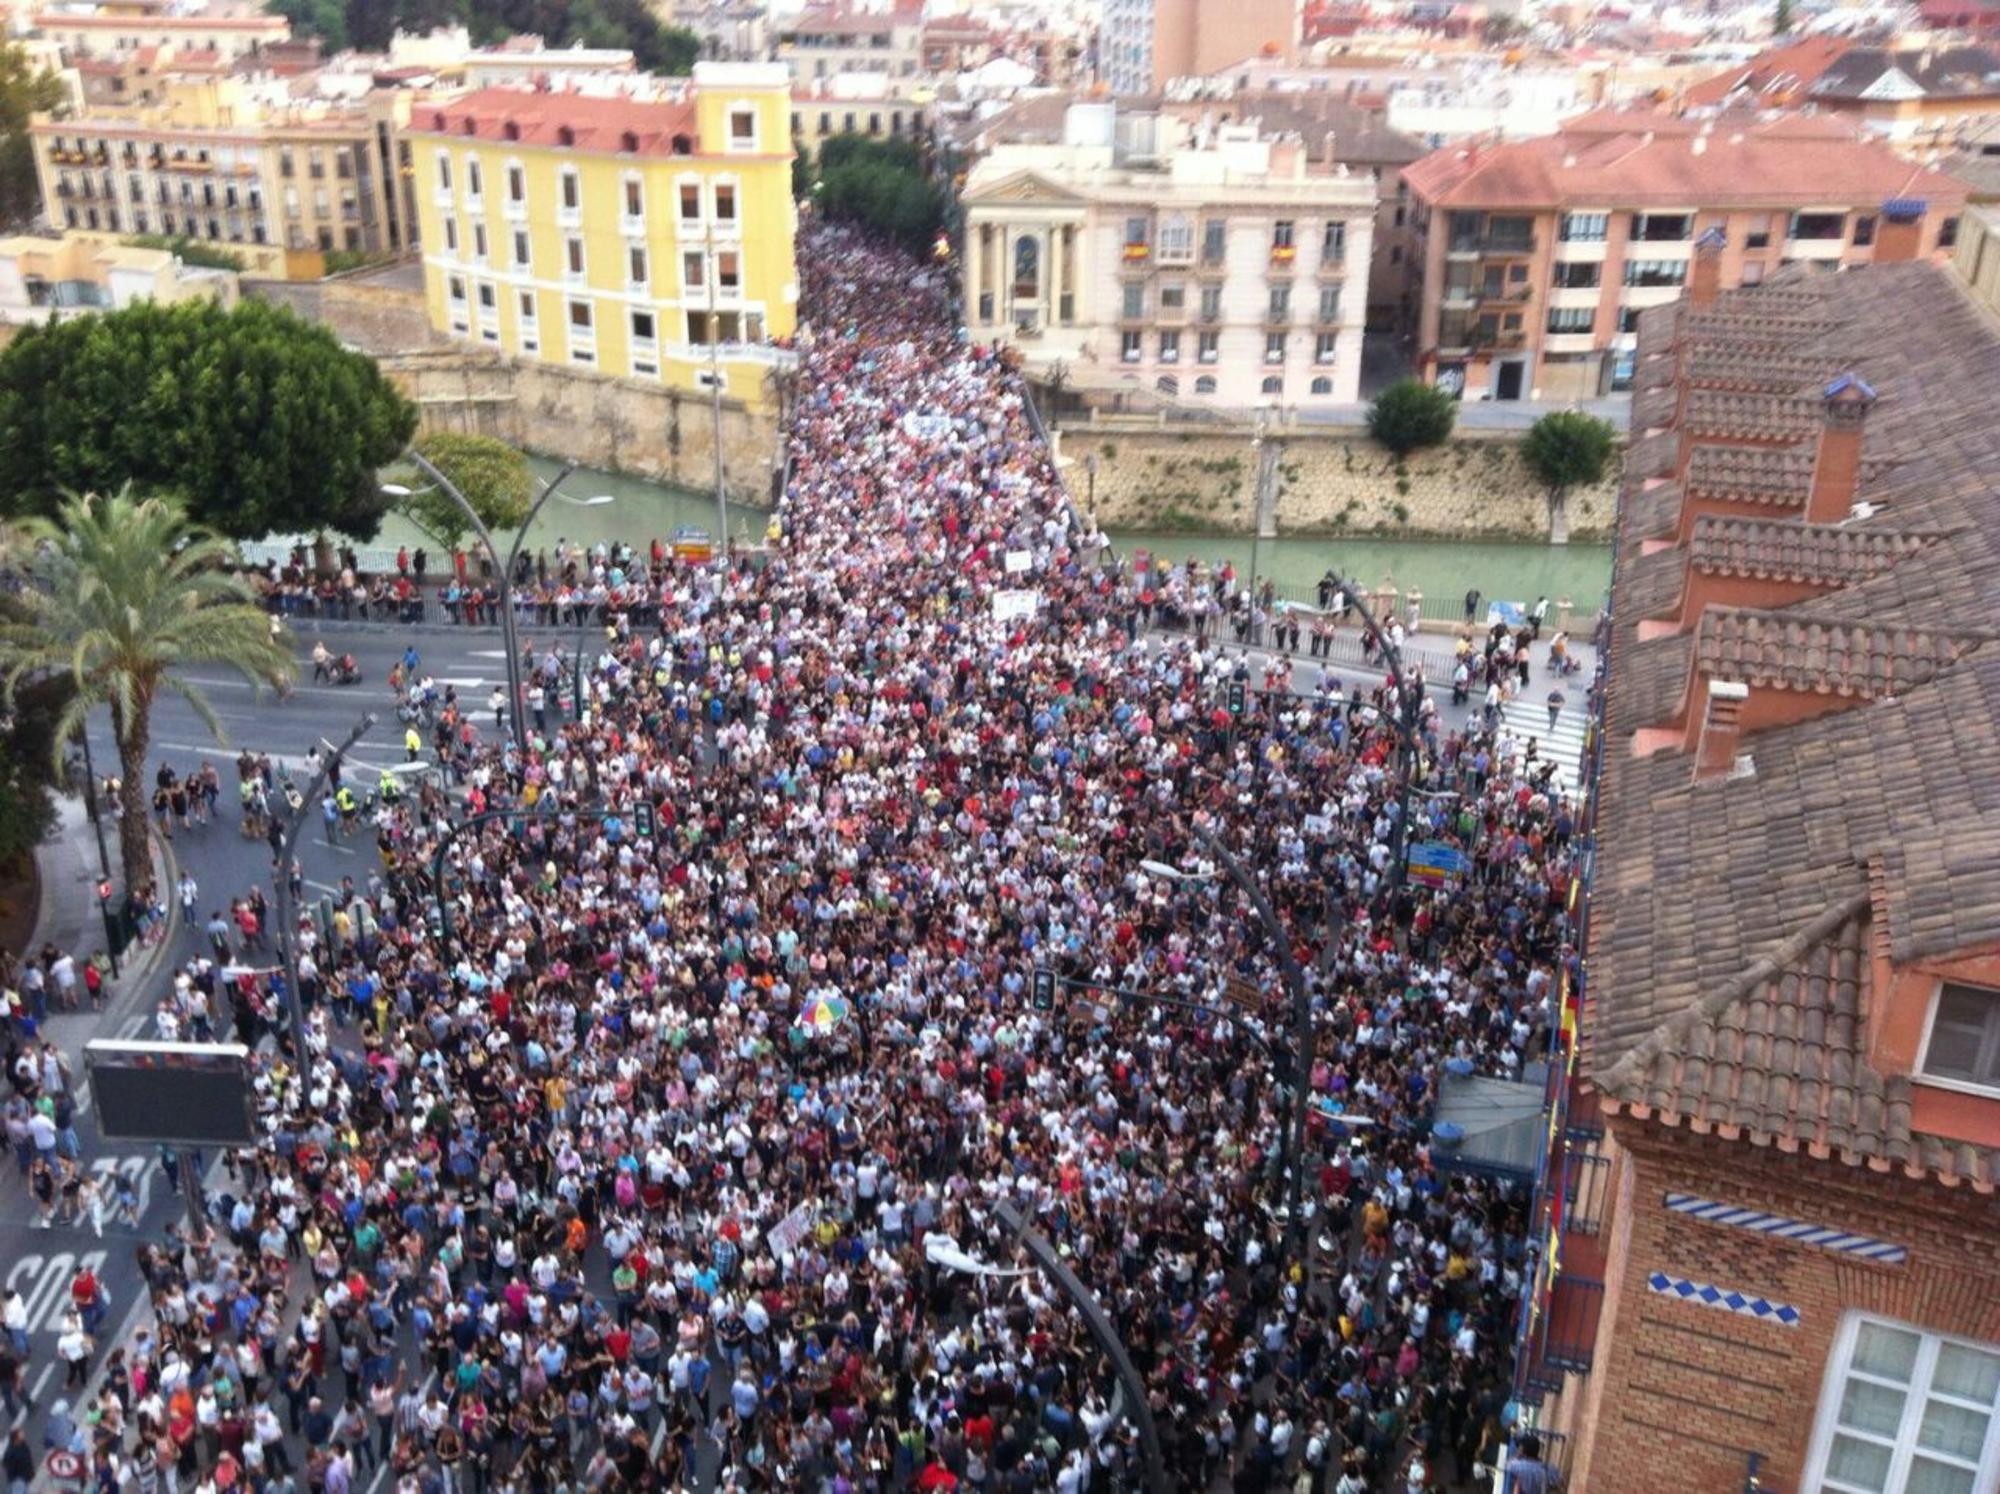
[960,102,1376,410]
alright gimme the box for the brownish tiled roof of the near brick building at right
[1584,264,2000,1188]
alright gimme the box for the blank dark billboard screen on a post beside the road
[84,1040,256,1146]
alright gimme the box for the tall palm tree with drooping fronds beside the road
[0,488,292,888]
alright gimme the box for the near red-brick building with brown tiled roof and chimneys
[1522,260,2000,1494]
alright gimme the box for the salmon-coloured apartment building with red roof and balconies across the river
[1404,110,1966,400]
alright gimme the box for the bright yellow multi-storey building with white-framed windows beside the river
[410,62,798,408]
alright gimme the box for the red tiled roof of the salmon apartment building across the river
[1402,114,1966,212]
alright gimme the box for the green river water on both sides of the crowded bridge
[364,458,1612,614]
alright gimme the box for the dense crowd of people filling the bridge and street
[7,226,1572,1494]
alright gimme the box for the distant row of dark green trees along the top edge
[264,0,702,76]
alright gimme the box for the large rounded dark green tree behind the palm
[0,300,416,540]
